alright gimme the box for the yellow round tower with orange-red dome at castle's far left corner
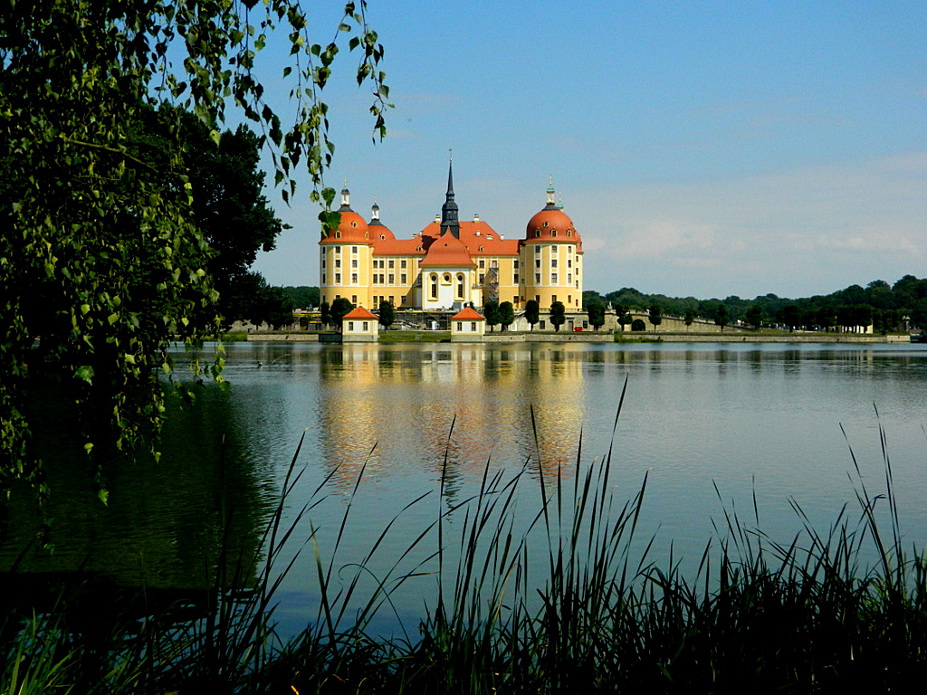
[319,188,373,307]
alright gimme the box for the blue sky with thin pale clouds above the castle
[248,0,927,299]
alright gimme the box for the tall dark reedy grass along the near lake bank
[0,392,927,695]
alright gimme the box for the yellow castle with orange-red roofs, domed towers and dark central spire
[319,161,583,312]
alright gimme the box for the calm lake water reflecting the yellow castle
[0,343,927,625]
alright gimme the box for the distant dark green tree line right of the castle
[583,275,927,333]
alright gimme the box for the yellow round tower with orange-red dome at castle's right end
[519,183,583,312]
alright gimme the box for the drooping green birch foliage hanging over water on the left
[0,0,388,497]
